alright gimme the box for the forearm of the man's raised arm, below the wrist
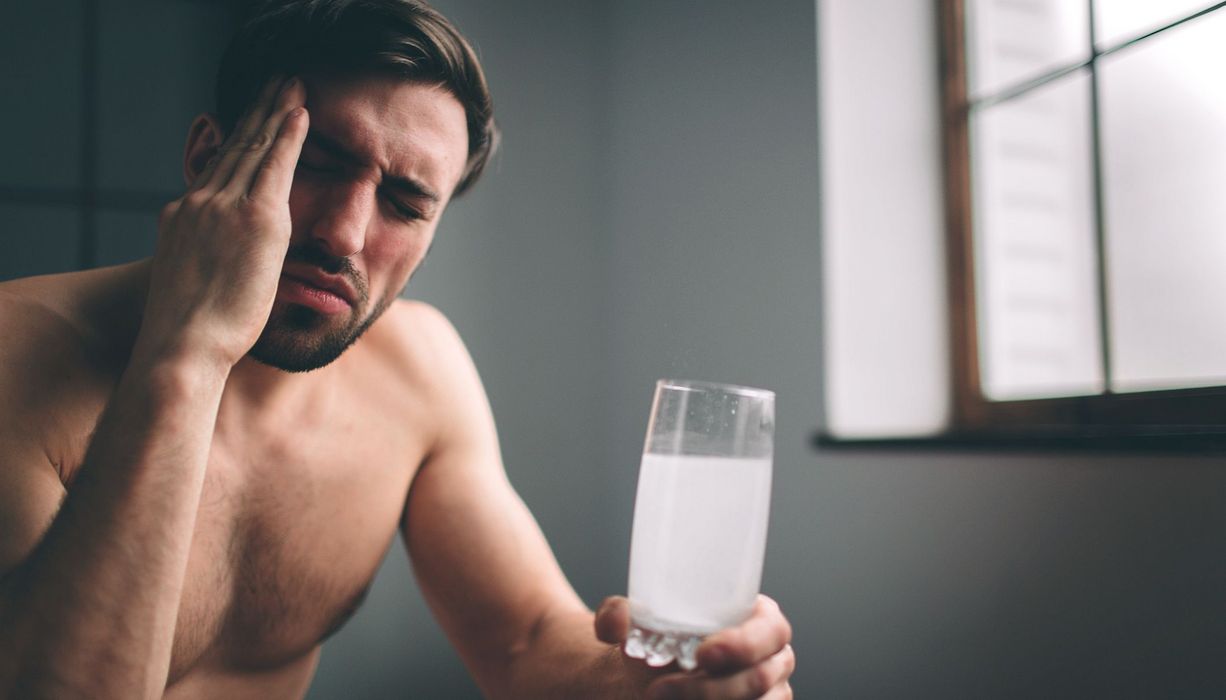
[0,359,227,698]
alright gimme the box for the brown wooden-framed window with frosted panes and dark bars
[942,0,1226,434]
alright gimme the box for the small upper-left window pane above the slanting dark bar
[966,0,1090,98]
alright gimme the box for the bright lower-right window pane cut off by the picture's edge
[1100,12,1226,391]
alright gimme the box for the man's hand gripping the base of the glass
[596,596,796,700]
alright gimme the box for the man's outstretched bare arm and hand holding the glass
[402,311,793,699]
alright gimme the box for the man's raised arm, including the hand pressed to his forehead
[0,78,307,699]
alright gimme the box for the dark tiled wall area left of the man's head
[0,0,233,278]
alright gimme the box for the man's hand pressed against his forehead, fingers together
[137,78,308,370]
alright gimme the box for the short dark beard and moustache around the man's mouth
[242,244,392,371]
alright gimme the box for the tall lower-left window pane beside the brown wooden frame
[971,71,1103,400]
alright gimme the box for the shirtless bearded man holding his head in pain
[0,0,794,699]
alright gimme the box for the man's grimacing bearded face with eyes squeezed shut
[251,72,468,371]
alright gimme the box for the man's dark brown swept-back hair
[217,0,499,195]
